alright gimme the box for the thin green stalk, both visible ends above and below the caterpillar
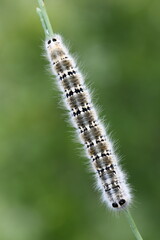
[37,0,143,240]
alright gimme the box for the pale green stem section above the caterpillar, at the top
[37,0,53,38]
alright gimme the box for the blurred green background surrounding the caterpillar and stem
[0,0,160,240]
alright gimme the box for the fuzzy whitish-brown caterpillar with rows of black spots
[45,34,131,209]
